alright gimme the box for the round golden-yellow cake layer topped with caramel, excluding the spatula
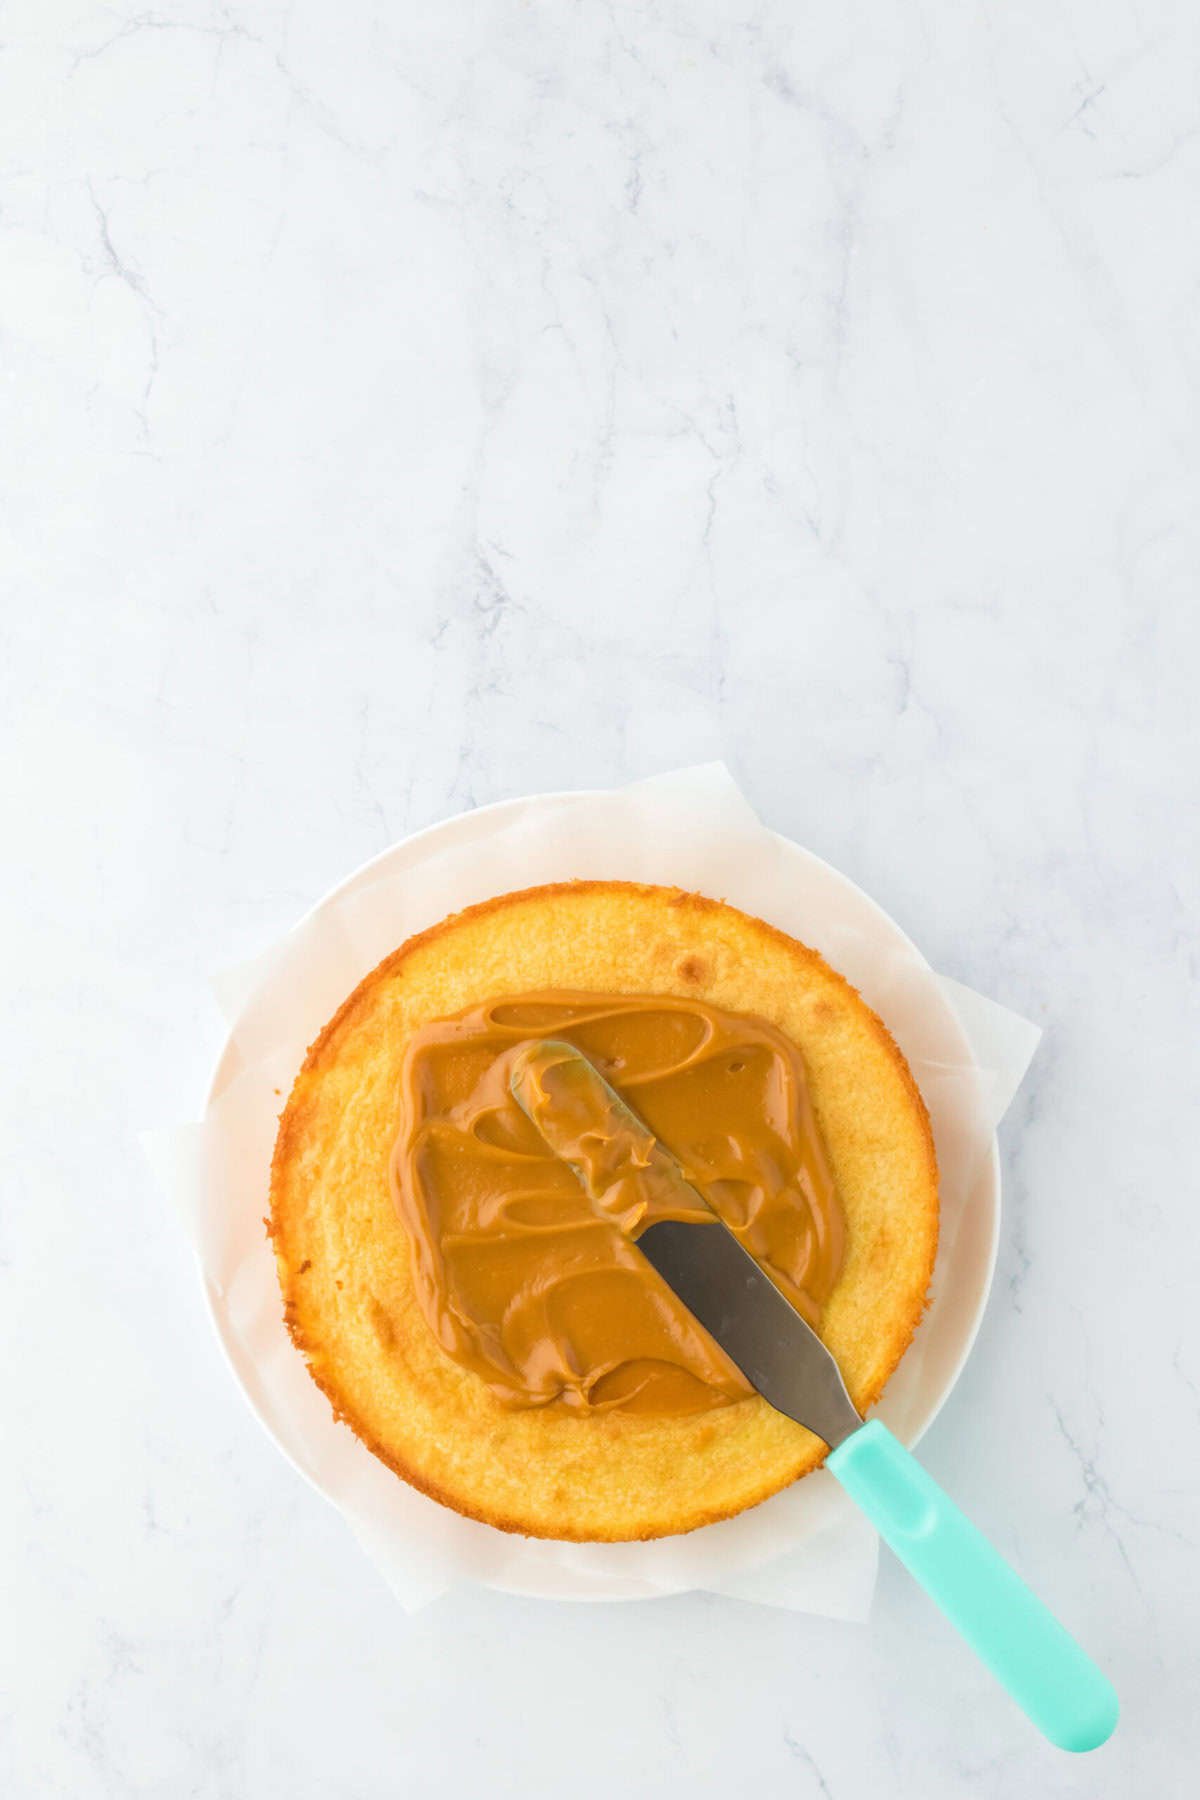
[270,882,937,1539]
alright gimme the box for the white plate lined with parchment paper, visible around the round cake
[144,763,1040,1620]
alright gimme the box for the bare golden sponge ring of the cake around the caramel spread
[268,882,937,1541]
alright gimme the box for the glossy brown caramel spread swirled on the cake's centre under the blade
[392,992,844,1413]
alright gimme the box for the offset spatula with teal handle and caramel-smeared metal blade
[513,1040,1117,1750]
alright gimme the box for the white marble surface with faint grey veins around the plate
[0,0,1200,1800]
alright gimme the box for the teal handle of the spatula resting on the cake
[826,1418,1117,1750]
